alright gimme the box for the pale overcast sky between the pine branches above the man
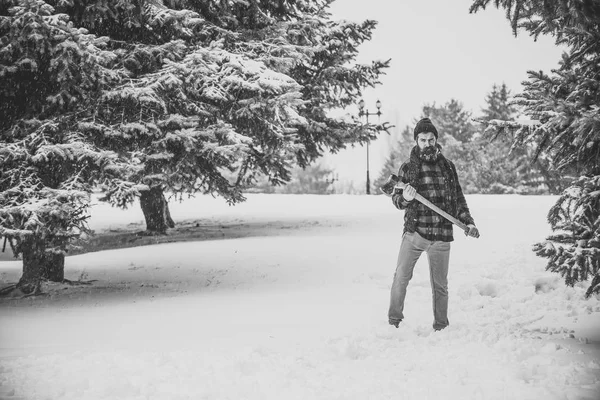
[325,0,563,186]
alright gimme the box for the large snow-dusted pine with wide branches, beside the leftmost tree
[52,0,387,232]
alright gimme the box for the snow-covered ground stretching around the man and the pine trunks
[0,195,600,400]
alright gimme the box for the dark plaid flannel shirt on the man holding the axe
[392,162,474,242]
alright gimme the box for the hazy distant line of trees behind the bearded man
[255,83,575,195]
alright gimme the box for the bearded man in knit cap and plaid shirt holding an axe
[388,118,479,331]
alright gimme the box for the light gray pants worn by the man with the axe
[388,232,450,329]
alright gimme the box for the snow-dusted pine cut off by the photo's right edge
[471,0,600,296]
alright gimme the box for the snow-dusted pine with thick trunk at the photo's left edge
[0,0,124,293]
